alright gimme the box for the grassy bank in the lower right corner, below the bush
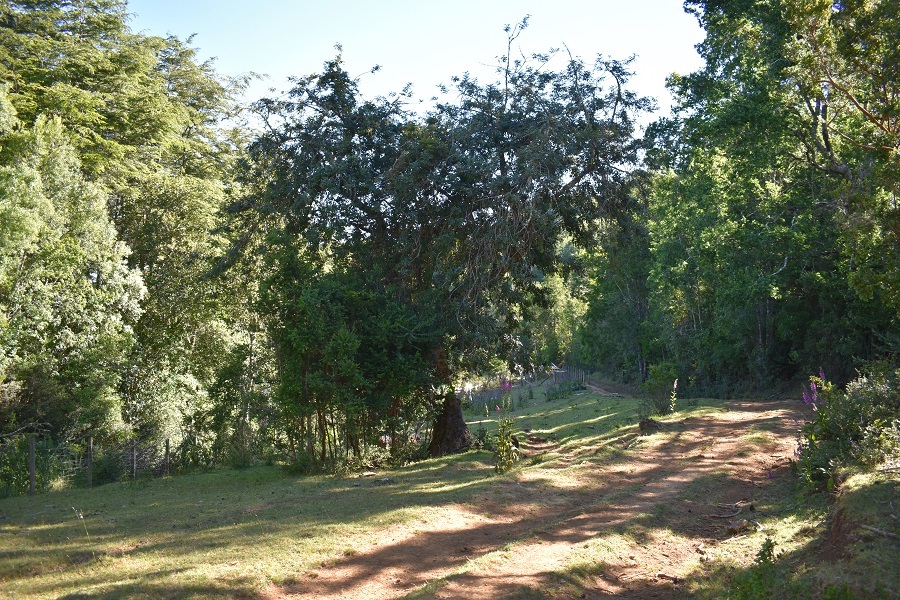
[685,472,900,600]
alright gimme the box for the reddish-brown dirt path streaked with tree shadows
[264,402,800,599]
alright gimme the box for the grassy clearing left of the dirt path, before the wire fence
[0,452,500,598]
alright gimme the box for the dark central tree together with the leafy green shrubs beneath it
[235,24,648,462]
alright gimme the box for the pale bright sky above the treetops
[128,0,703,124]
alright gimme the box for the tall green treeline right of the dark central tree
[580,0,900,395]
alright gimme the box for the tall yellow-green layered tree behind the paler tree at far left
[0,0,247,435]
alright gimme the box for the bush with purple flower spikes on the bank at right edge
[797,363,900,489]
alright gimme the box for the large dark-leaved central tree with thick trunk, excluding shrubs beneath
[239,28,647,455]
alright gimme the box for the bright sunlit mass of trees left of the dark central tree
[0,0,248,450]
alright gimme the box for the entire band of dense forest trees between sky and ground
[0,0,900,486]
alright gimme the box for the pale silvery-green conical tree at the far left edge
[0,109,145,436]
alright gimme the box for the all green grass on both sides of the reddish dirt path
[0,382,898,598]
